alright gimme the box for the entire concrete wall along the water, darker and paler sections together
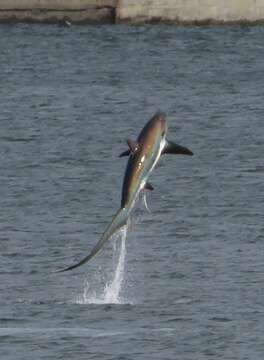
[0,0,264,24]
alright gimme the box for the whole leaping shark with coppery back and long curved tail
[57,112,193,272]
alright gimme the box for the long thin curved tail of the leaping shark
[55,208,129,272]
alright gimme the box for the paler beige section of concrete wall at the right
[117,0,264,23]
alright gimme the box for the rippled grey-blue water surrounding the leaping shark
[0,25,264,360]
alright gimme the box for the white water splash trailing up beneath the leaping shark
[76,226,127,304]
